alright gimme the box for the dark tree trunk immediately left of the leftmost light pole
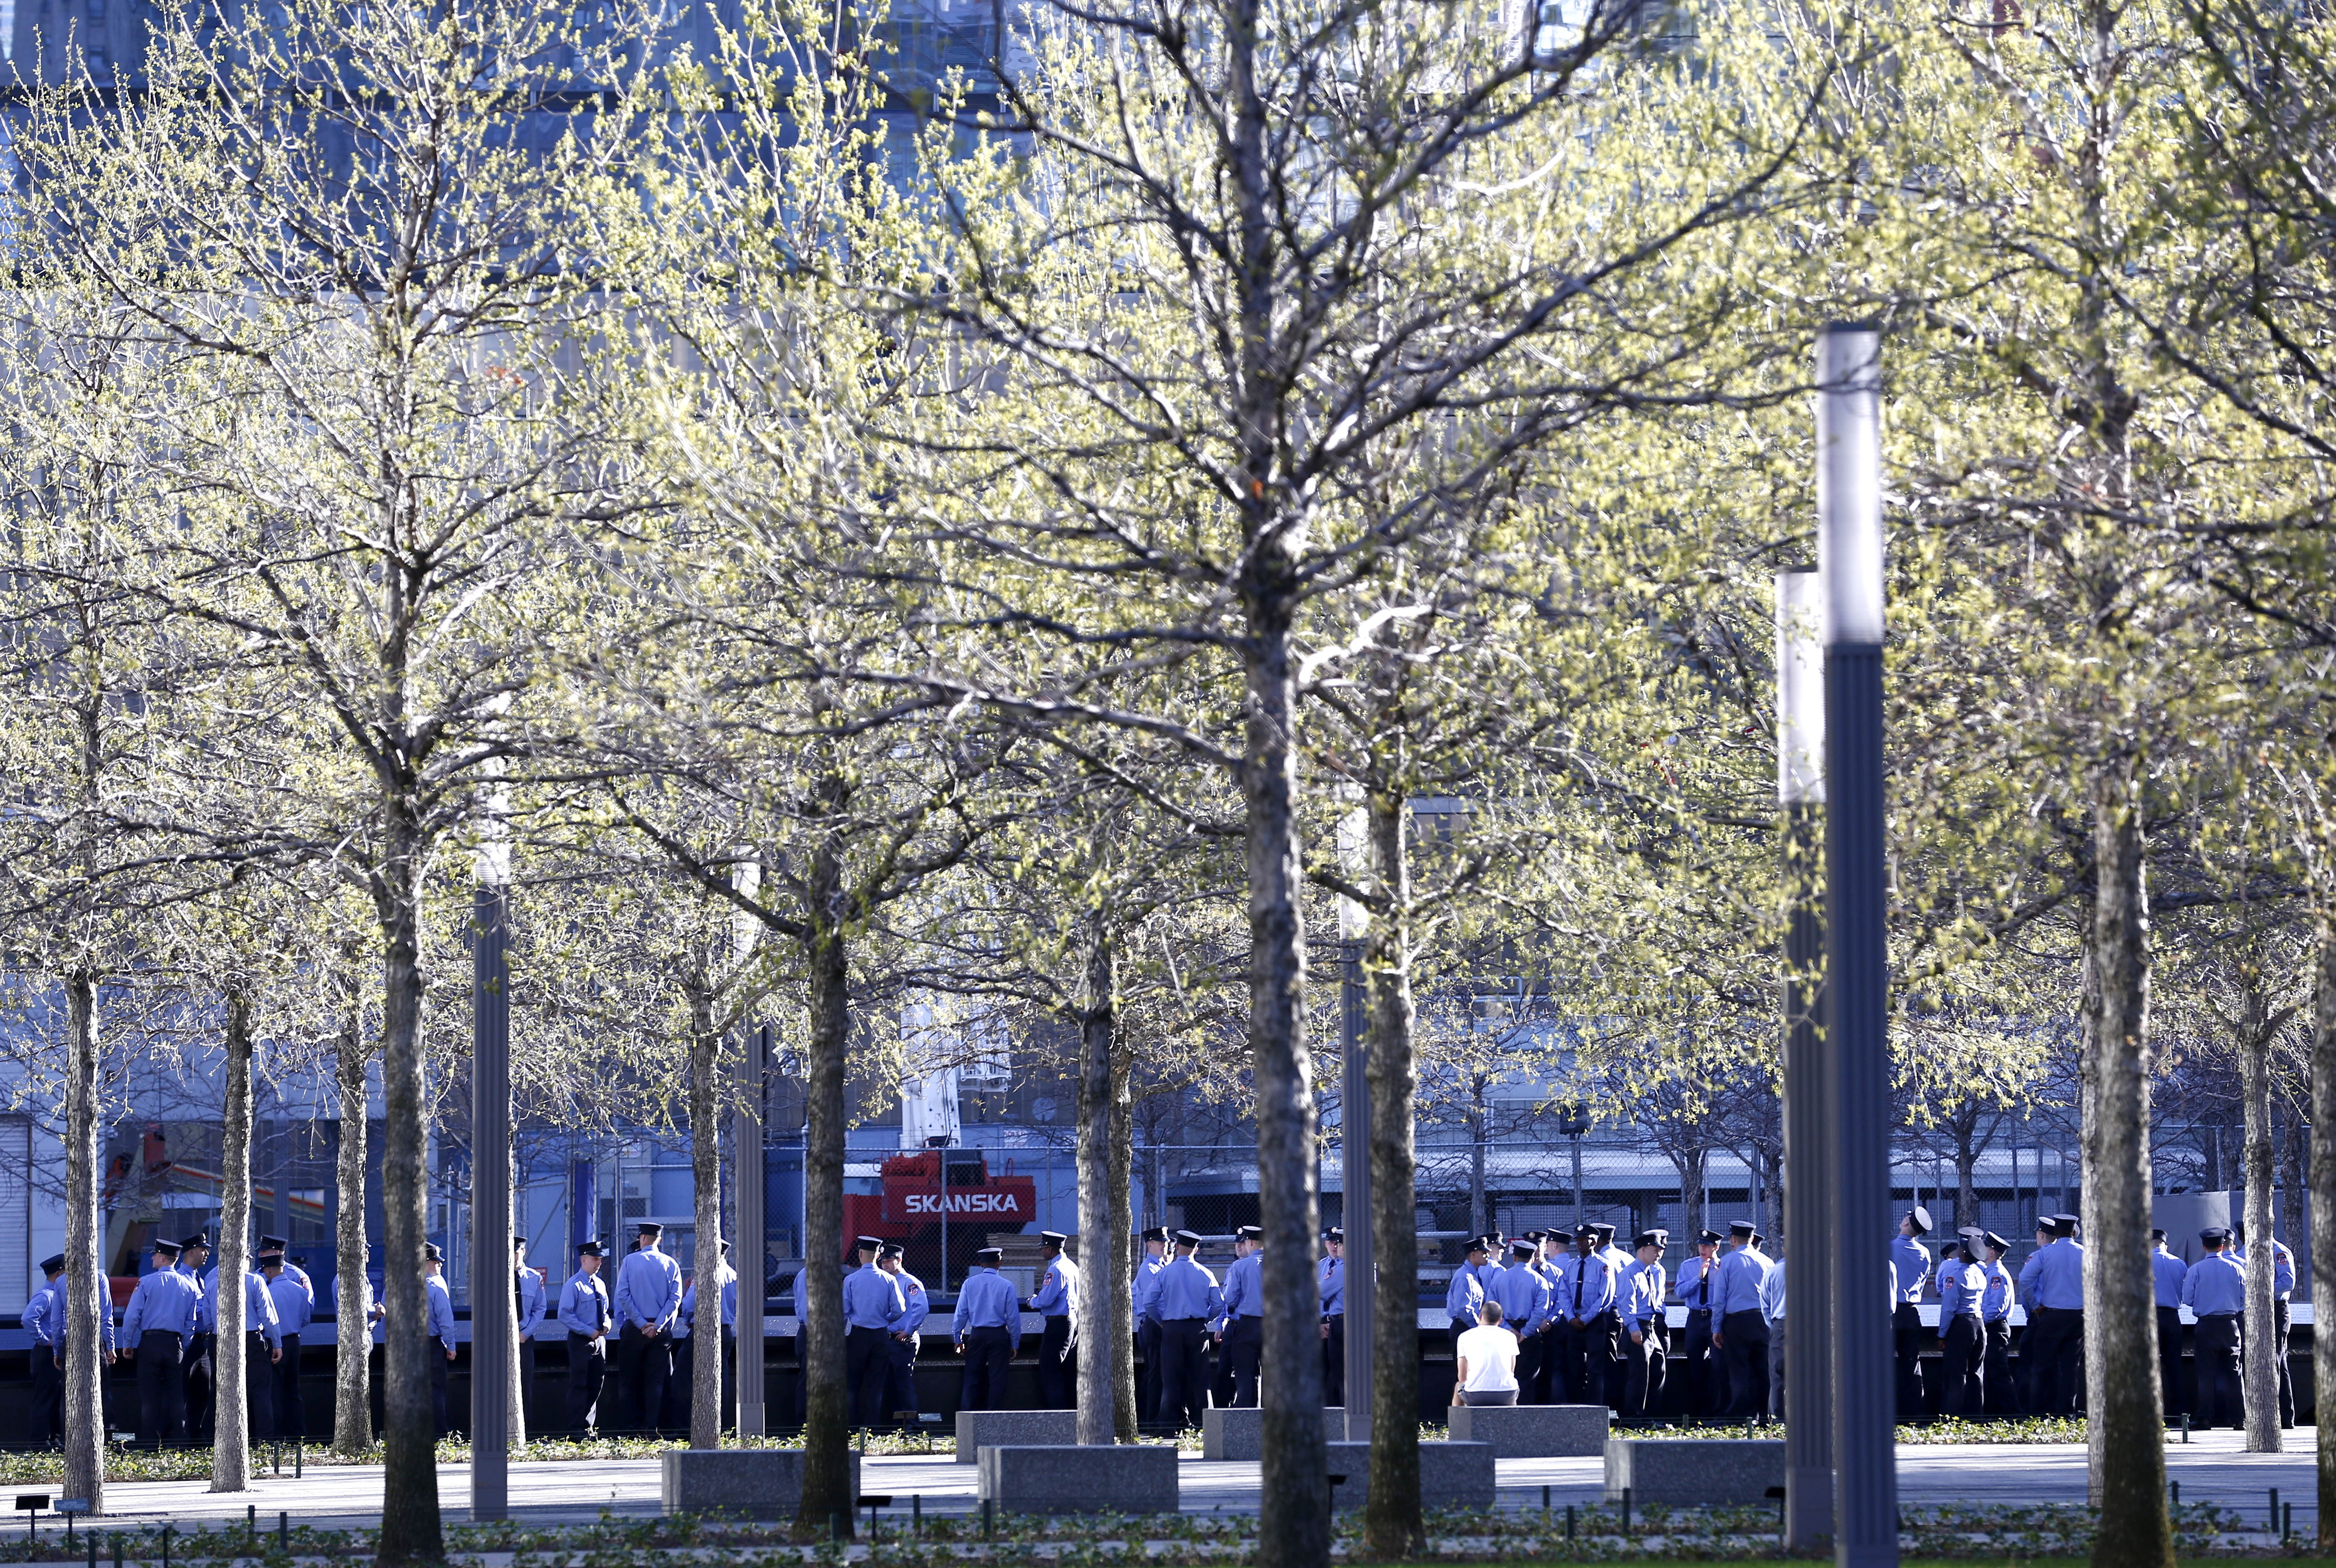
[378,883,446,1568]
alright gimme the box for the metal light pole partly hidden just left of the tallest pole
[1775,568,1834,1552]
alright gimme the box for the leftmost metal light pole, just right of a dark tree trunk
[470,816,516,1521]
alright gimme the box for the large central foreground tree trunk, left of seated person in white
[1243,617,1329,1568]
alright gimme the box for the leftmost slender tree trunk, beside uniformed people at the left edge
[63,970,112,1514]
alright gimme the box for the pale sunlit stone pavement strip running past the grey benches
[64,1428,2315,1528]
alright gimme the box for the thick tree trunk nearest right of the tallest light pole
[2081,757,2175,1568]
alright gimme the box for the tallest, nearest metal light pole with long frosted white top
[1787,323,1897,1568]
